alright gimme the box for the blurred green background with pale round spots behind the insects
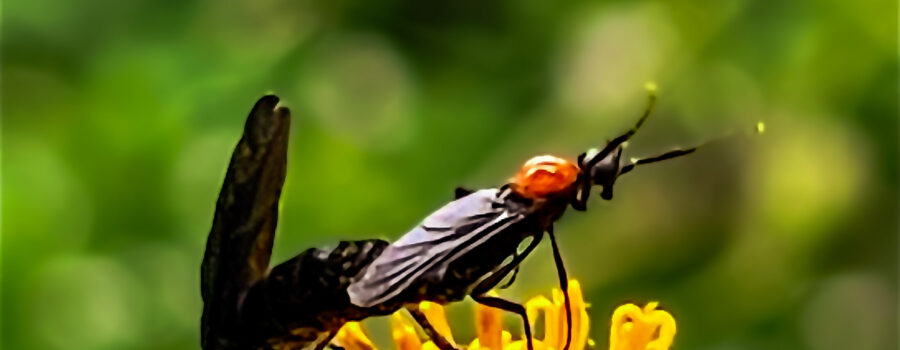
[2,0,900,350]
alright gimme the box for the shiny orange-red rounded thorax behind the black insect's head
[513,156,579,198]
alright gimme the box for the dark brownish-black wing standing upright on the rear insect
[200,95,290,349]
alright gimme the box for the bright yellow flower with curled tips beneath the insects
[333,280,675,350]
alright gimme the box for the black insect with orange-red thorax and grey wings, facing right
[348,88,694,349]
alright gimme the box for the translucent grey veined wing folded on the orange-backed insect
[348,189,523,307]
